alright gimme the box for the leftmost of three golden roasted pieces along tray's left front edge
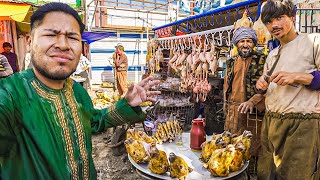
[124,138,150,163]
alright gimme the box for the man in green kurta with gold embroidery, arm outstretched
[0,3,160,180]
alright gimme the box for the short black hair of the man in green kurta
[31,2,85,34]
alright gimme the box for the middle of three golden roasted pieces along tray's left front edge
[148,143,169,174]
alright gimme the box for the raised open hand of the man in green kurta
[125,76,161,107]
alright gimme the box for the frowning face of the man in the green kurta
[29,12,82,80]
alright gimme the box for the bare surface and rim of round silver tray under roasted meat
[128,133,249,180]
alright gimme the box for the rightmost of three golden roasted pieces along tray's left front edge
[169,152,193,180]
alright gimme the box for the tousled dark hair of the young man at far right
[261,0,296,24]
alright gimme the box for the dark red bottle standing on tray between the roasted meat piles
[190,118,206,150]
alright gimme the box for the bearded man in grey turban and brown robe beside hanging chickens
[224,27,266,155]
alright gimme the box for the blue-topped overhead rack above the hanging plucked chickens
[152,0,265,37]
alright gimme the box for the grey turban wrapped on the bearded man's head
[232,27,258,46]
